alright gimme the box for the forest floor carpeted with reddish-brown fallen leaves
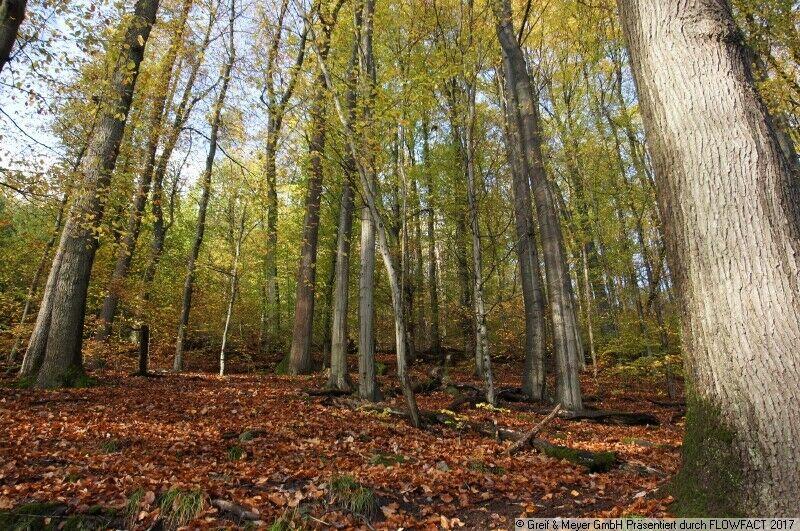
[0,344,683,529]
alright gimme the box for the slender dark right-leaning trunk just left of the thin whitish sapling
[172,7,236,372]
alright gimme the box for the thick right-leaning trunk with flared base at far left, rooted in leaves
[22,0,158,387]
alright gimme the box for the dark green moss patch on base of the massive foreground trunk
[670,393,746,517]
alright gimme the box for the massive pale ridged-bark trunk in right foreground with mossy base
[620,0,800,516]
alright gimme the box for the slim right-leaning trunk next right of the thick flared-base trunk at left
[98,0,193,339]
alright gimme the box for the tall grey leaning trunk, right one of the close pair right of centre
[492,0,583,411]
